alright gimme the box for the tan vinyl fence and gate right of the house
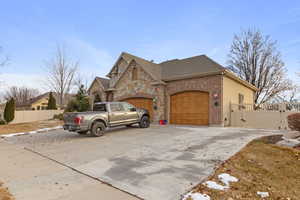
[230,103,300,130]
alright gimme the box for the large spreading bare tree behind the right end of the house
[228,29,293,105]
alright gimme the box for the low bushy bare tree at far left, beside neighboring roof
[4,86,40,105]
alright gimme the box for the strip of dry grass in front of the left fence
[0,120,63,135]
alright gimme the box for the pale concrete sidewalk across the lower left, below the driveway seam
[0,140,136,200]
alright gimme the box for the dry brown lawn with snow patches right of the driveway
[188,136,300,200]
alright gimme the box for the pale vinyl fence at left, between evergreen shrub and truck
[11,110,63,124]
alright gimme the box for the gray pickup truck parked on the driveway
[63,102,150,137]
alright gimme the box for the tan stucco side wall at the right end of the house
[223,76,254,126]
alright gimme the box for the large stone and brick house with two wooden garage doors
[88,53,257,126]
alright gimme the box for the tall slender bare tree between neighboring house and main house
[45,46,79,107]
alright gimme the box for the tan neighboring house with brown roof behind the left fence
[16,92,74,110]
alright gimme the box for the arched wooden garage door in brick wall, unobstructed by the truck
[170,91,209,125]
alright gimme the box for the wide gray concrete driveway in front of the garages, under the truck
[0,125,280,200]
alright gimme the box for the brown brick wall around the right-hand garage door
[165,75,222,125]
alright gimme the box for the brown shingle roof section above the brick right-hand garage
[160,55,225,80]
